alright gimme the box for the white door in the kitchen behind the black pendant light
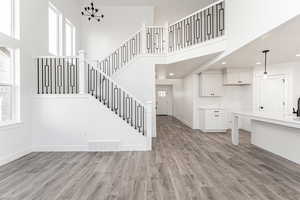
[258,75,287,114]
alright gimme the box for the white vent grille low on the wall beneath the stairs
[88,140,120,152]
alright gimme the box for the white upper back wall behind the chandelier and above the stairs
[81,5,153,60]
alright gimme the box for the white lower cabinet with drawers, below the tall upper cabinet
[199,108,226,132]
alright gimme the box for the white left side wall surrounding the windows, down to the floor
[0,0,79,165]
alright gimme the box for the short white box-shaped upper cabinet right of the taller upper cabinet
[224,68,252,85]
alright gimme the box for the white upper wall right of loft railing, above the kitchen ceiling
[195,0,300,73]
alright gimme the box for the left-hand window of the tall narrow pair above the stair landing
[49,3,62,56]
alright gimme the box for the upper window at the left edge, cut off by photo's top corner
[0,0,19,38]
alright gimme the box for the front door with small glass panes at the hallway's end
[156,86,173,115]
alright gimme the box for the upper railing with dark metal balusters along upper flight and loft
[96,0,225,76]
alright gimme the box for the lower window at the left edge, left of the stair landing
[0,47,18,122]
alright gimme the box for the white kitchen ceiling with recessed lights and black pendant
[212,16,300,69]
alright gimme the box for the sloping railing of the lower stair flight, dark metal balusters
[87,63,147,135]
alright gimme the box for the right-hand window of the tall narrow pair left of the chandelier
[65,19,76,56]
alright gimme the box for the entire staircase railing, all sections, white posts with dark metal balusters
[36,0,225,150]
